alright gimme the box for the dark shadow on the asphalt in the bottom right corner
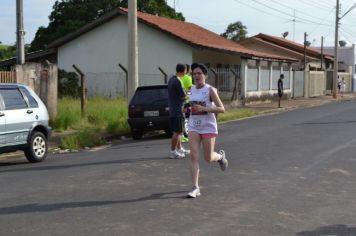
[297,224,356,236]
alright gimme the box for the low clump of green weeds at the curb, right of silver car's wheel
[60,129,105,150]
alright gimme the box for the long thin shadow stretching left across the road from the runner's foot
[0,191,186,215]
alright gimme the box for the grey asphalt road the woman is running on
[0,101,356,236]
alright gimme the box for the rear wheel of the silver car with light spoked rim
[25,132,47,162]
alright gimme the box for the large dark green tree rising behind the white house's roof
[30,0,185,52]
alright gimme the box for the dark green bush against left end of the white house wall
[58,70,80,98]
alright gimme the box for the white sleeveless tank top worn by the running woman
[188,84,218,134]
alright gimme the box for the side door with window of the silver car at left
[0,87,34,145]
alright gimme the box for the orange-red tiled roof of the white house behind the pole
[48,8,297,61]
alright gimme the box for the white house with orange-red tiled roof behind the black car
[44,8,295,96]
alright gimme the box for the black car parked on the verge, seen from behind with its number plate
[128,85,172,139]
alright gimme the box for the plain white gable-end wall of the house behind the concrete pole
[58,16,192,95]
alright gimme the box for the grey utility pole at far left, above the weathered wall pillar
[16,0,25,65]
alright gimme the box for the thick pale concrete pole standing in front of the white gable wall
[127,0,138,102]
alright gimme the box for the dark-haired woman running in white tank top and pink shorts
[187,63,228,198]
